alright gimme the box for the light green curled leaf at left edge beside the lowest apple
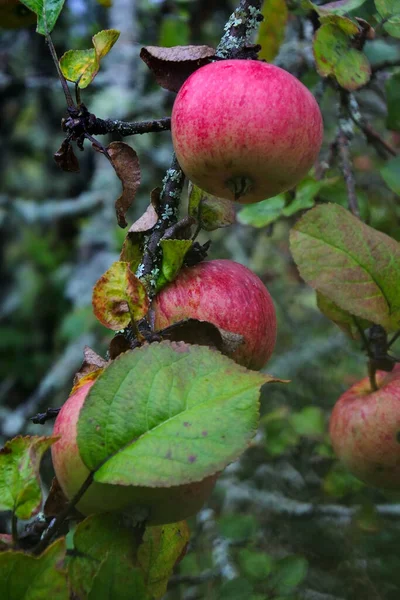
[0,435,57,519]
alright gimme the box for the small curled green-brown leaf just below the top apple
[189,182,235,231]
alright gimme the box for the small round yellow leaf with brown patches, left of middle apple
[92,261,149,331]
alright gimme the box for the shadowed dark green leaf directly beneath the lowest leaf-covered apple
[67,514,142,600]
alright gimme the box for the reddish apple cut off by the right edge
[329,365,400,490]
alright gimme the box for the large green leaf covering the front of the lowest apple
[78,342,271,487]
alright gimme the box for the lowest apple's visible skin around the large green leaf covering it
[51,381,219,525]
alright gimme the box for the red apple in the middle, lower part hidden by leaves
[152,259,276,370]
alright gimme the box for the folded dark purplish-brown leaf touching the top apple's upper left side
[140,46,215,92]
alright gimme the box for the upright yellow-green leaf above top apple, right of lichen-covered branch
[256,0,288,62]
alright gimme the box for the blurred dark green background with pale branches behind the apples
[0,0,400,600]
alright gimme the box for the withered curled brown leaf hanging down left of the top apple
[107,142,140,227]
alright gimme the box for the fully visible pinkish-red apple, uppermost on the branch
[171,60,323,204]
